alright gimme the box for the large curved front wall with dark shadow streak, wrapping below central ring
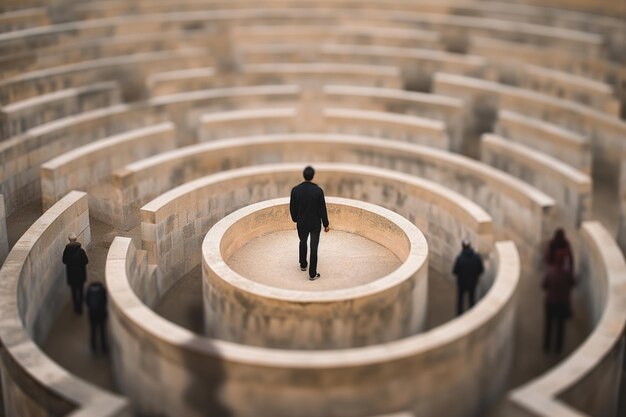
[106,237,520,417]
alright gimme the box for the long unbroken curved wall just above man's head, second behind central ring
[113,134,544,265]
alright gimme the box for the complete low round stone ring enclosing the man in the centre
[202,198,428,349]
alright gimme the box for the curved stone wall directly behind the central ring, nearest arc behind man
[141,163,494,294]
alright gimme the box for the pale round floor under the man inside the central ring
[226,226,402,291]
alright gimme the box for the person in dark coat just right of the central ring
[452,239,485,316]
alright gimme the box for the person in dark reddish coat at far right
[542,229,575,353]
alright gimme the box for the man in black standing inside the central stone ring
[289,166,329,281]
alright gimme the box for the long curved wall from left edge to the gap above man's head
[0,82,297,217]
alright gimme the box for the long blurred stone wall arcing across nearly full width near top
[0,3,601,69]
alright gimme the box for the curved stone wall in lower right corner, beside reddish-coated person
[504,222,626,417]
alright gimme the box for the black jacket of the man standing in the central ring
[289,181,328,230]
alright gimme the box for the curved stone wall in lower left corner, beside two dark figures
[0,192,129,417]
